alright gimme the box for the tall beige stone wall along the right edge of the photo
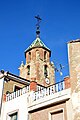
[68,39,80,120]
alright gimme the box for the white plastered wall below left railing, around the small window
[1,93,28,120]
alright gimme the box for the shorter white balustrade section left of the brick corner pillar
[6,86,30,101]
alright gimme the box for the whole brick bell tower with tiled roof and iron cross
[19,16,55,86]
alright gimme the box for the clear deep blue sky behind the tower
[0,0,80,81]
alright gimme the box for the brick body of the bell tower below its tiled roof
[19,47,55,85]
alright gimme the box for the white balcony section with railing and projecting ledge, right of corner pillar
[28,81,71,112]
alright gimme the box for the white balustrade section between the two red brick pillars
[32,81,65,101]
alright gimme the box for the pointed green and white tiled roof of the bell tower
[25,38,50,52]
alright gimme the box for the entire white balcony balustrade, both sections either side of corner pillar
[6,81,66,101]
